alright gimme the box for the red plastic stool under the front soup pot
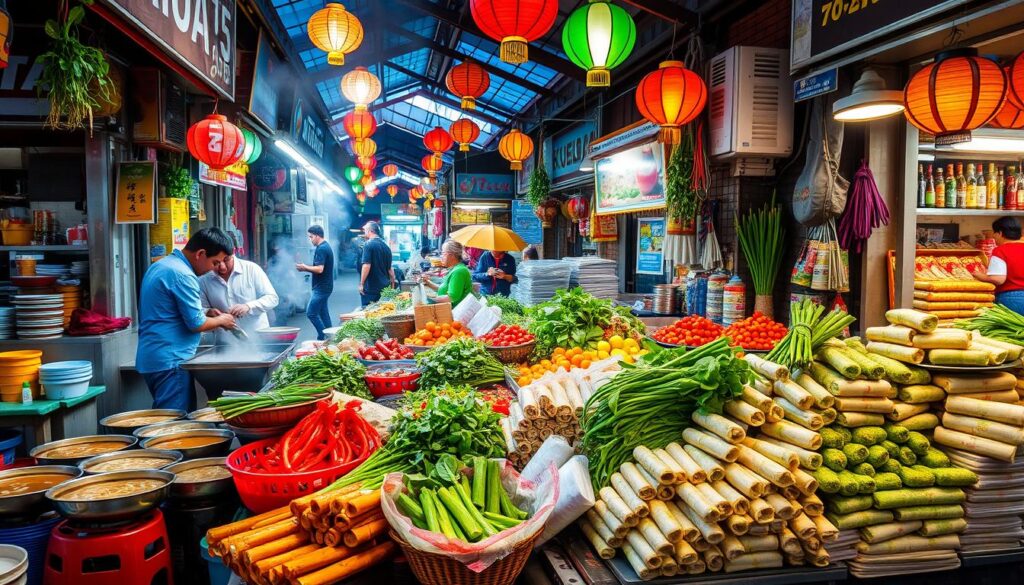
[43,510,174,585]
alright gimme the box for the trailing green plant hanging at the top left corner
[36,0,118,130]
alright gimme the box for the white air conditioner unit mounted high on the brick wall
[708,47,793,158]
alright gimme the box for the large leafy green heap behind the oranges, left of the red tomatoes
[527,287,646,358]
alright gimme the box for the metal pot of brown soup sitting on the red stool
[46,469,174,521]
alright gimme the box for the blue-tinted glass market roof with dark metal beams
[261,0,695,175]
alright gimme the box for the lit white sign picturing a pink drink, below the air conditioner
[594,142,665,215]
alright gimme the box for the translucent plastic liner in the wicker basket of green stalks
[381,461,558,573]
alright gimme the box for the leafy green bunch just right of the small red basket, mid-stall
[416,338,505,390]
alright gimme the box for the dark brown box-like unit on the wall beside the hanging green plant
[131,68,188,151]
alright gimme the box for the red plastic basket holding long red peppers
[226,437,370,513]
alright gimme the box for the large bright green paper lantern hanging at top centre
[562,0,637,87]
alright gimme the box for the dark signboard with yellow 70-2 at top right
[790,0,970,71]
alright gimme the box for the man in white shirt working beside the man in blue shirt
[200,256,279,334]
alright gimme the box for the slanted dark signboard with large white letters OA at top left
[93,0,237,99]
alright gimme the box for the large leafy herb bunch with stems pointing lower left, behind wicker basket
[330,385,505,490]
